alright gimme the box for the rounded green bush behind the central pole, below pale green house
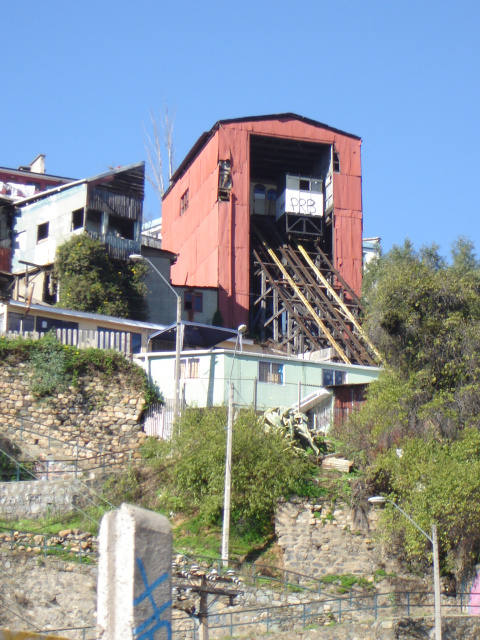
[145,407,318,531]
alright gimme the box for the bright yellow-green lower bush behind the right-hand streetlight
[370,428,480,578]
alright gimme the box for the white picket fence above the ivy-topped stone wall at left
[3,329,132,358]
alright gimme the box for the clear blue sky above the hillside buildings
[0,0,480,254]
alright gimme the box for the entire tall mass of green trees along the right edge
[337,238,480,575]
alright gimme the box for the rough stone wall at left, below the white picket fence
[0,363,145,468]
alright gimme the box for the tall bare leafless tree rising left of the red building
[143,100,176,202]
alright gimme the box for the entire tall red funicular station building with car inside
[162,113,362,360]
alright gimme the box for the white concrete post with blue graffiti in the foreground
[97,504,172,640]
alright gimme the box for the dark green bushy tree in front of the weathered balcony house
[55,234,147,320]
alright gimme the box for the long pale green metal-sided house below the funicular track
[136,349,380,428]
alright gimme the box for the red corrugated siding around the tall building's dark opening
[162,114,362,326]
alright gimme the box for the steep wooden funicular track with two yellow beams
[252,225,380,366]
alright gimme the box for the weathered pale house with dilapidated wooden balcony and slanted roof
[12,163,145,303]
